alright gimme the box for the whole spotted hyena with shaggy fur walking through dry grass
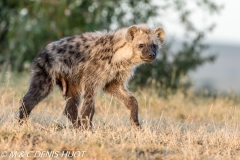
[19,25,165,127]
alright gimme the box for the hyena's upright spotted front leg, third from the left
[80,85,95,129]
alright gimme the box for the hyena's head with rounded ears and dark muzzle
[125,25,165,62]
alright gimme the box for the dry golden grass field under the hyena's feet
[0,73,240,160]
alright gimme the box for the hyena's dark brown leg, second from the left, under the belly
[63,82,81,128]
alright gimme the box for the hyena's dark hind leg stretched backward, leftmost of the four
[19,63,54,122]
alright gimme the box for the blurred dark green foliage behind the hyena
[0,0,221,90]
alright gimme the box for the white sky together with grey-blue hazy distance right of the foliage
[163,0,240,93]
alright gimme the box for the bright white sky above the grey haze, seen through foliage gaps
[165,0,240,45]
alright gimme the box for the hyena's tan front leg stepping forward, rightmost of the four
[104,80,140,128]
